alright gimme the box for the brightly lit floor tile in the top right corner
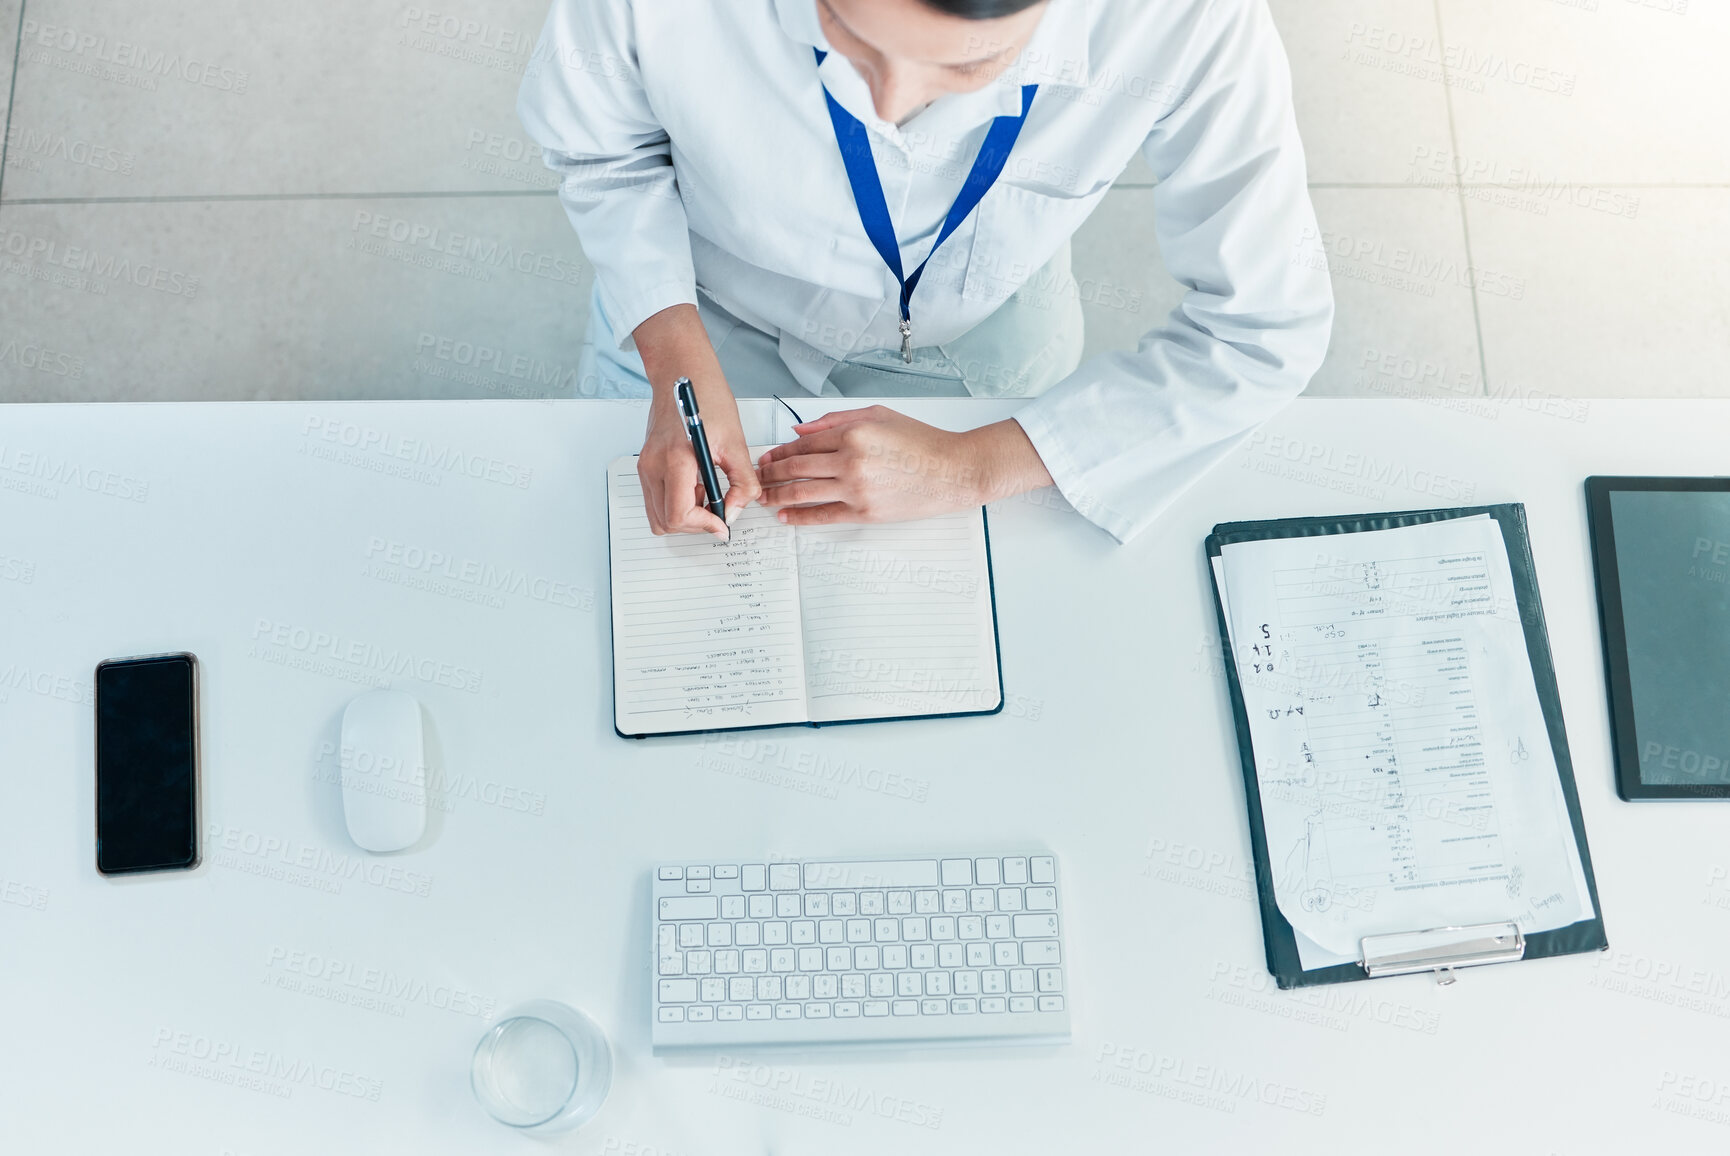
[1441,0,1730,189]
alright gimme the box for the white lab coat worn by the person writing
[519,0,1334,540]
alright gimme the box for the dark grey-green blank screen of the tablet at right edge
[1609,490,1730,787]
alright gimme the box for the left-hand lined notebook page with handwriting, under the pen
[607,450,806,734]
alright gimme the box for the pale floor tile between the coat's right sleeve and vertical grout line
[1308,189,1480,396]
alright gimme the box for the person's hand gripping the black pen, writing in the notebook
[633,305,763,542]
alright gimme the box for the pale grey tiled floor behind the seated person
[0,0,1730,400]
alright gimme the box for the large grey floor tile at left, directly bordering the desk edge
[0,196,592,401]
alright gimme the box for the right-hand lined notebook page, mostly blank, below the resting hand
[799,511,1003,722]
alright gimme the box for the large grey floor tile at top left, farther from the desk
[5,0,555,199]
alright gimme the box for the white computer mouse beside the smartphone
[343,690,427,853]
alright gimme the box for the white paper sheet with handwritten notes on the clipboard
[1221,517,1590,967]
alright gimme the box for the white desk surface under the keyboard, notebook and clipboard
[0,401,1730,1156]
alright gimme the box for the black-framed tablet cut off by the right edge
[1586,478,1730,800]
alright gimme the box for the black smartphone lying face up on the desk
[97,654,199,876]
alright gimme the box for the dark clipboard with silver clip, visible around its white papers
[1206,502,1609,990]
